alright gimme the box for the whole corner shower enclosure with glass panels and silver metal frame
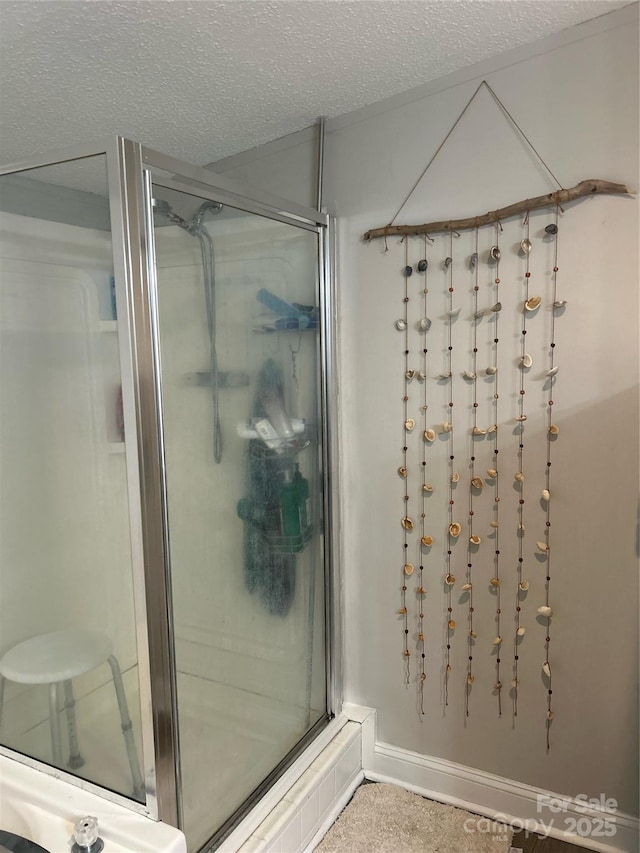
[0,138,338,853]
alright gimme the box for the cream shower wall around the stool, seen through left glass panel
[0,208,140,793]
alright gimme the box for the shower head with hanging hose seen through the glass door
[153,198,222,464]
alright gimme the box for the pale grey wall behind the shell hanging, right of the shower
[215,4,638,814]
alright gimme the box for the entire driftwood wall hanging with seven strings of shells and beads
[364,81,630,749]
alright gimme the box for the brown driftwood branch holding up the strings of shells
[364,178,635,240]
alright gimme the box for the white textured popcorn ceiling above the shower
[0,0,627,165]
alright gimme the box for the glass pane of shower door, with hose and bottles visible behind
[153,185,327,850]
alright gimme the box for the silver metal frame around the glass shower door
[132,140,341,826]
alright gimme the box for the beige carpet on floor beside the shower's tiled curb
[315,784,513,853]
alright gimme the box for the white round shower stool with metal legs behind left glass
[0,630,144,799]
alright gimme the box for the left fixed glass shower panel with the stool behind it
[0,156,144,800]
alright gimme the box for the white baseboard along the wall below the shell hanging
[363,738,640,853]
